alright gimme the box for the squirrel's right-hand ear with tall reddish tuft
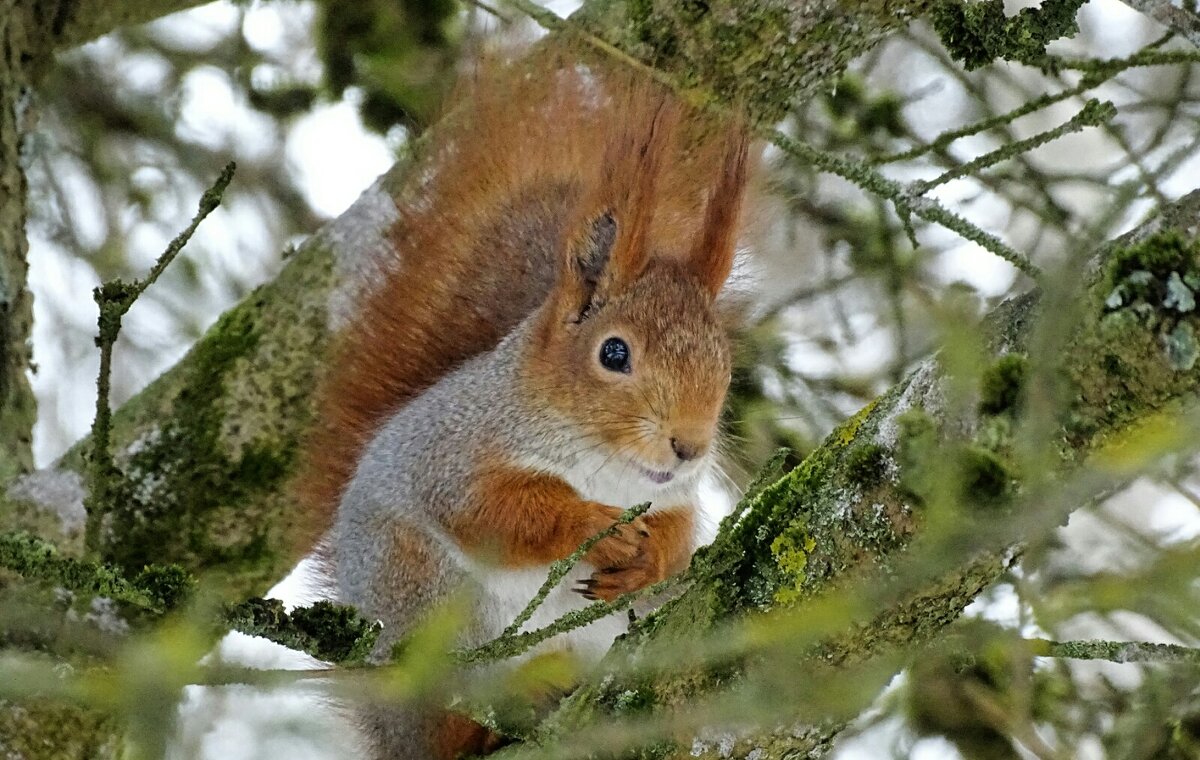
[688,124,750,298]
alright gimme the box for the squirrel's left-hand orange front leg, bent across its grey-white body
[448,466,650,568]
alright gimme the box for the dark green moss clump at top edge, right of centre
[929,0,1085,71]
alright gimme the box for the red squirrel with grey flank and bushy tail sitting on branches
[302,51,748,758]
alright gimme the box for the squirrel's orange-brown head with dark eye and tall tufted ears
[524,100,746,484]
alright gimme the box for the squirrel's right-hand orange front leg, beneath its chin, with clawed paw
[577,507,696,602]
